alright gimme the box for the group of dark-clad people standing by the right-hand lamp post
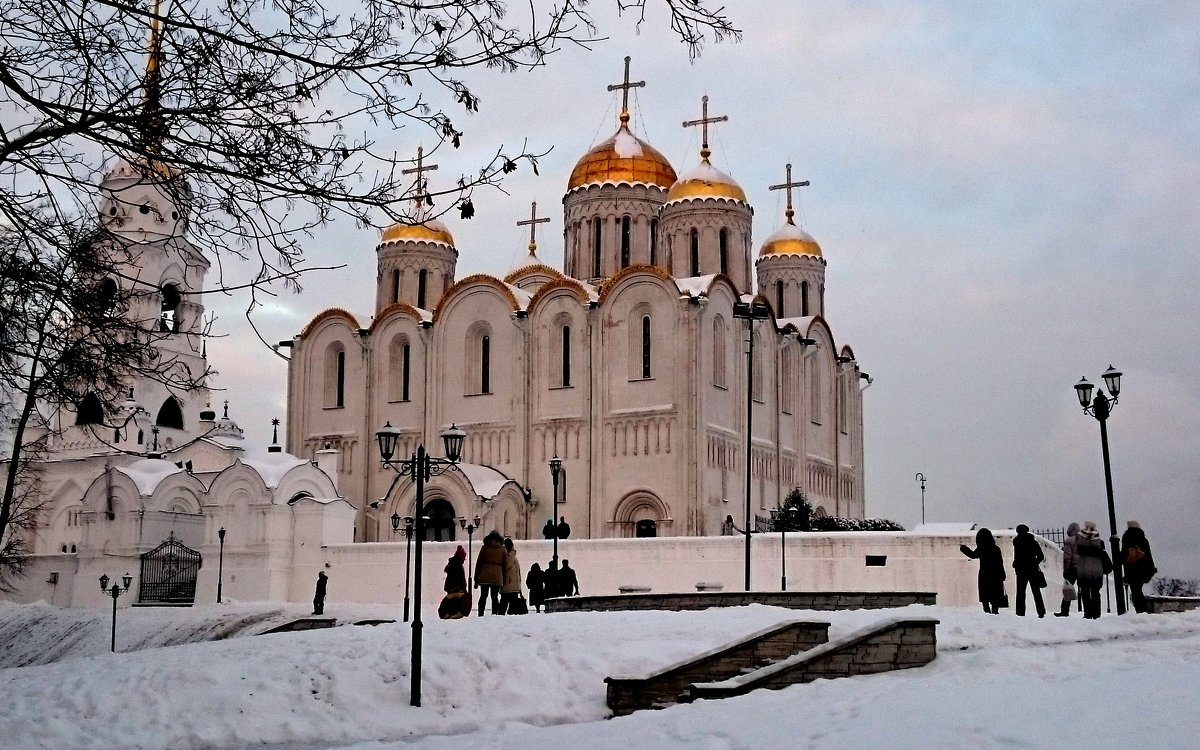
[959,521,1158,619]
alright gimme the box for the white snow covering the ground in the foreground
[0,604,1200,750]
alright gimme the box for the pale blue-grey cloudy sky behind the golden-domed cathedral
[201,0,1200,576]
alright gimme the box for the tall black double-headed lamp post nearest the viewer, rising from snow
[376,421,467,706]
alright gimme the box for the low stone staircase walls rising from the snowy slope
[605,618,937,716]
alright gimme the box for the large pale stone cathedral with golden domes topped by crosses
[290,74,870,541]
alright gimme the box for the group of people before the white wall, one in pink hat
[438,530,580,619]
